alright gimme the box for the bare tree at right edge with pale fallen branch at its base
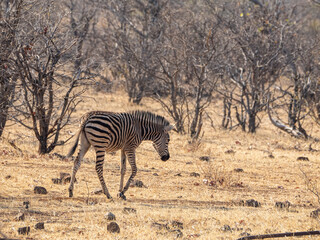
[268,3,320,138]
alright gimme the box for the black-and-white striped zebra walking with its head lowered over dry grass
[66,111,174,200]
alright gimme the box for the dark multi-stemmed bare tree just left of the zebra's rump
[12,0,91,154]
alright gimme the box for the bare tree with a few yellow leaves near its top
[213,1,291,133]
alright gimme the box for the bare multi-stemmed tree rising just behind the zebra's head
[154,2,223,139]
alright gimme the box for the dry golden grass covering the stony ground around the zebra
[0,89,320,239]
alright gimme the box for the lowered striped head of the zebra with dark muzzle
[153,125,174,161]
